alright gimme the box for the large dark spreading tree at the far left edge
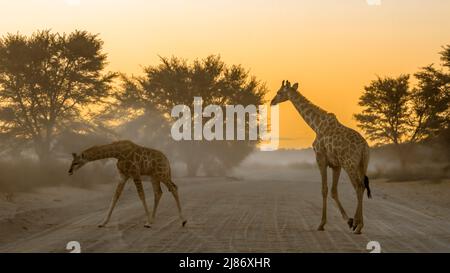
[0,31,115,159]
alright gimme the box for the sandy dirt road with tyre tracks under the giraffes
[0,170,450,252]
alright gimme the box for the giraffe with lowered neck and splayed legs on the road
[69,141,187,227]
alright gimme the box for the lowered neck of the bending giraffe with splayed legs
[83,142,134,161]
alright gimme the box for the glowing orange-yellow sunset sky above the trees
[0,0,450,148]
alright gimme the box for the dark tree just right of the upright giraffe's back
[355,75,411,144]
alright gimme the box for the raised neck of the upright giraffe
[289,92,330,134]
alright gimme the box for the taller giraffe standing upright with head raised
[271,81,372,234]
